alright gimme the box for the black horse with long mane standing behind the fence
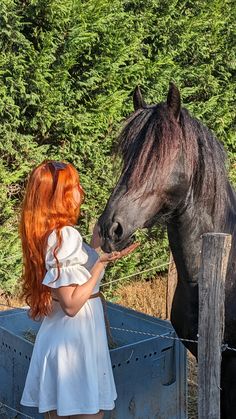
[99,83,236,419]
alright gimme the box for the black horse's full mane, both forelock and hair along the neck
[118,103,227,223]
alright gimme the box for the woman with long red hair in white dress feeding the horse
[20,161,136,419]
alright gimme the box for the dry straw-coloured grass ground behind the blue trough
[0,277,198,419]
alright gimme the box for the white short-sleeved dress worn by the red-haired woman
[21,226,117,416]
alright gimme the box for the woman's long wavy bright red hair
[20,161,84,319]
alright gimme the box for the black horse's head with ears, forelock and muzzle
[99,83,197,251]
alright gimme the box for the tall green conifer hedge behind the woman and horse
[0,0,236,293]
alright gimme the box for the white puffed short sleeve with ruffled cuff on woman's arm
[42,226,91,288]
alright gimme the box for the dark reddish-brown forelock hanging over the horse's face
[118,104,187,188]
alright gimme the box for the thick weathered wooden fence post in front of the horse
[198,233,231,419]
